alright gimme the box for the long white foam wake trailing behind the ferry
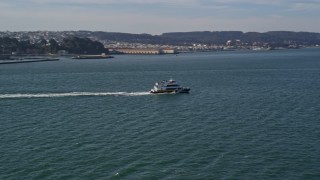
[0,92,150,99]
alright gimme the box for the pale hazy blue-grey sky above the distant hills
[0,0,320,34]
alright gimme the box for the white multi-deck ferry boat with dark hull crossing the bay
[150,79,190,94]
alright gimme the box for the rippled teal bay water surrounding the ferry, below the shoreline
[0,49,320,179]
